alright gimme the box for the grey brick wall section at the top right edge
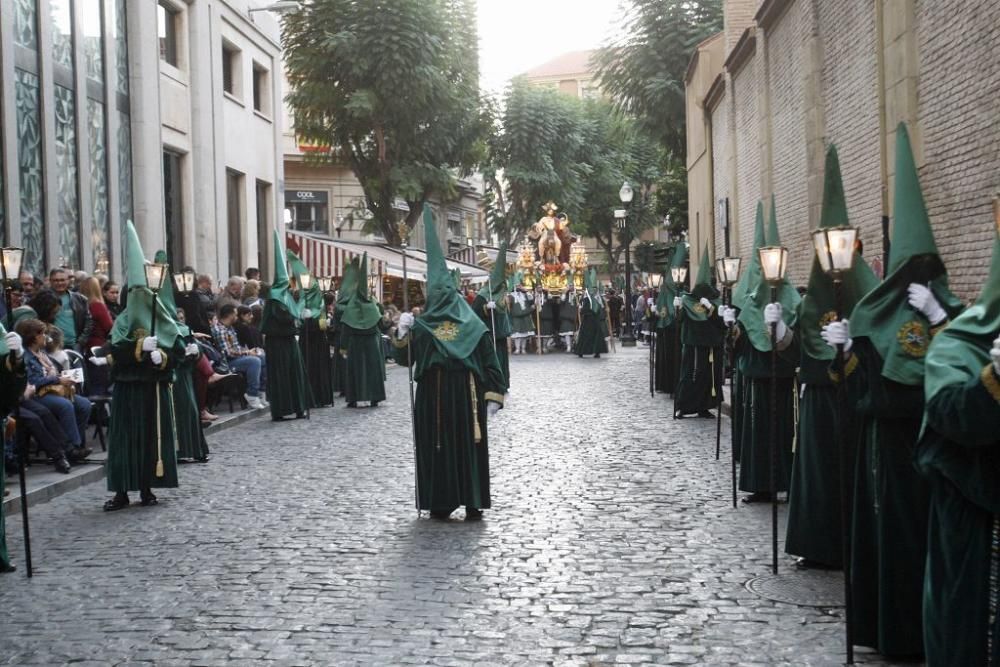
[916,0,1000,298]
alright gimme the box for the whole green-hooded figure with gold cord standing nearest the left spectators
[107,222,184,493]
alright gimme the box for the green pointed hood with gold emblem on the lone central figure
[413,204,489,369]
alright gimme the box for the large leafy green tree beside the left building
[283,0,487,243]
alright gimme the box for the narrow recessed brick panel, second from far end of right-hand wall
[732,60,761,264]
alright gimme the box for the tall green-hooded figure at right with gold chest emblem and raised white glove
[850,124,960,656]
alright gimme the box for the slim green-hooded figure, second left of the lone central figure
[287,250,334,408]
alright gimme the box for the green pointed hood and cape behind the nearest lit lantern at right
[792,145,878,361]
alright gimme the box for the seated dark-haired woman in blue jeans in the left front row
[16,319,91,459]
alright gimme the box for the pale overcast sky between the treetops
[478,0,618,92]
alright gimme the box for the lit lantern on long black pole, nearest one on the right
[813,226,858,665]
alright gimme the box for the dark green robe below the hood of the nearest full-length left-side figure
[107,336,184,493]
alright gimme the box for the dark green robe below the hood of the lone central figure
[394,329,504,513]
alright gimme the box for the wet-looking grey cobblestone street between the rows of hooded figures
[0,348,892,667]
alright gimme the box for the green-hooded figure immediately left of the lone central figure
[334,253,388,407]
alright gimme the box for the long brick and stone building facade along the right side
[687,0,1000,299]
